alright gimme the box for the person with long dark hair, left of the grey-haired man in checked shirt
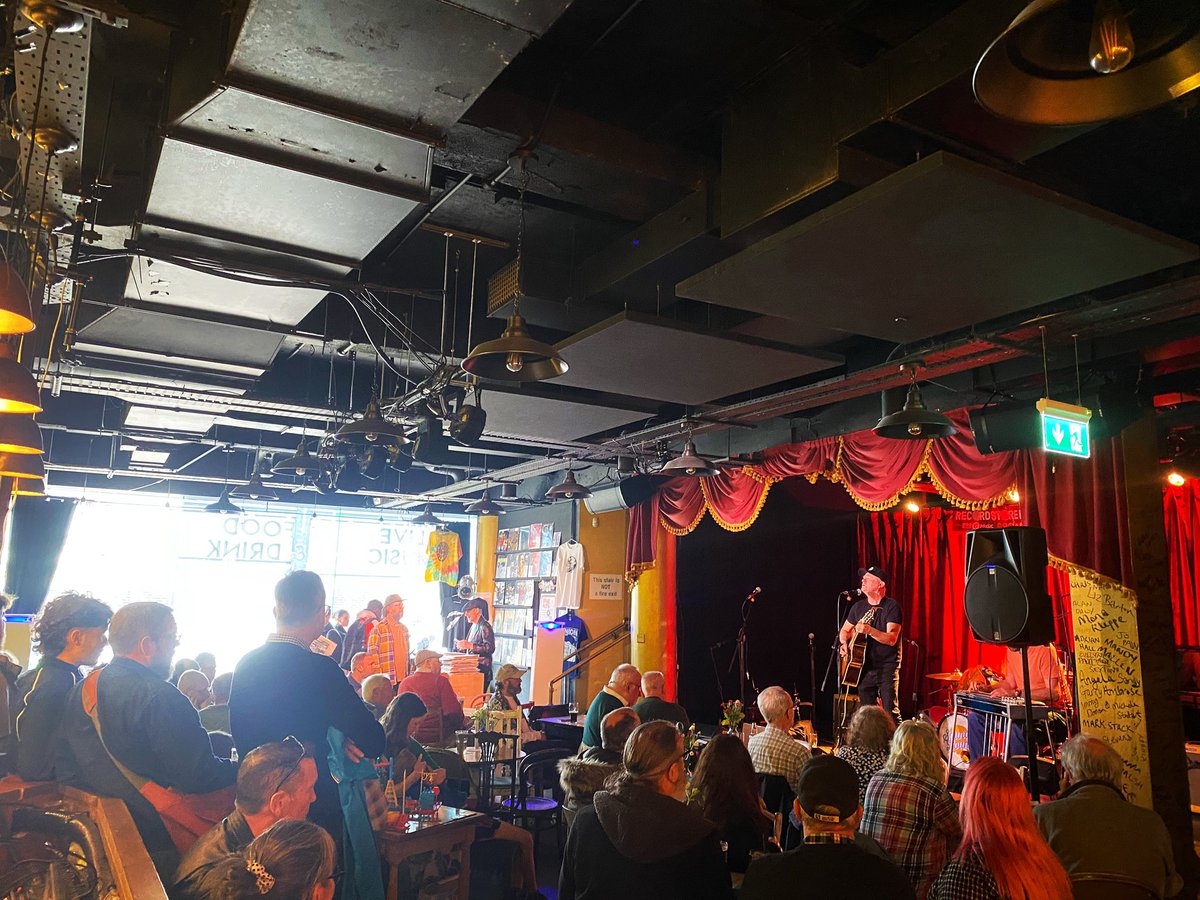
[691,734,775,872]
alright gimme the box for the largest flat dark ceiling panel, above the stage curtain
[677,152,1200,342]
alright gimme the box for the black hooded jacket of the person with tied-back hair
[558,787,733,900]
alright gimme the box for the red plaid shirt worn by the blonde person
[859,770,962,898]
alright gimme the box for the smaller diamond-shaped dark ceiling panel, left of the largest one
[554,312,844,404]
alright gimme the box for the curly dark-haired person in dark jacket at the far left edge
[12,593,113,781]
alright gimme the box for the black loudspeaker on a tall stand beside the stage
[962,526,1055,803]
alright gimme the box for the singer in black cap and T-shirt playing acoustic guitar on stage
[838,565,904,722]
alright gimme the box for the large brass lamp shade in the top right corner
[972,0,1200,125]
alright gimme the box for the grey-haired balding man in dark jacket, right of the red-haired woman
[1033,733,1183,896]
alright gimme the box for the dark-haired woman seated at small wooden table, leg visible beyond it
[379,694,538,890]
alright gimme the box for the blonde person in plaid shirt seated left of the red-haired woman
[862,720,962,898]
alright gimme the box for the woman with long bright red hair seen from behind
[929,756,1072,900]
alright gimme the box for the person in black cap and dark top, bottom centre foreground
[738,756,912,900]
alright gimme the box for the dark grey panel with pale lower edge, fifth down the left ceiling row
[78,307,283,374]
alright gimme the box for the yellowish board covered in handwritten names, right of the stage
[1070,572,1151,809]
